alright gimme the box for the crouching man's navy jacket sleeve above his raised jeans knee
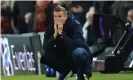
[62,21,84,50]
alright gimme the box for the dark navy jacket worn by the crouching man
[41,13,91,72]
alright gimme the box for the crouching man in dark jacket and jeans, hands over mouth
[41,6,92,80]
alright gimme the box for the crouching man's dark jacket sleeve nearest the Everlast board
[43,29,54,51]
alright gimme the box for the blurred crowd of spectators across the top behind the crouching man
[1,0,133,34]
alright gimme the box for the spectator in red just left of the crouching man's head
[33,1,49,32]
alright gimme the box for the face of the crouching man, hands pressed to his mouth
[54,11,67,24]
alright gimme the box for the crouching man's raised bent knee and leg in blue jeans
[72,48,92,80]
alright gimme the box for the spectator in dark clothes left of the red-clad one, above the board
[13,1,35,33]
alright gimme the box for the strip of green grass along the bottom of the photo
[1,72,133,80]
